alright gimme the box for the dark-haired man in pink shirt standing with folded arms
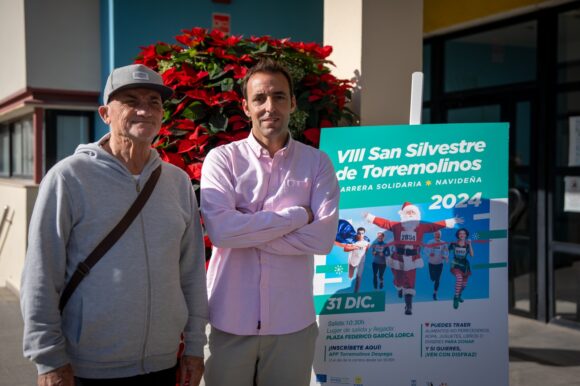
[201,61,339,386]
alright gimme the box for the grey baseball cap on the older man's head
[103,64,173,104]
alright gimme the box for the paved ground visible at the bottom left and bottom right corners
[0,288,580,386]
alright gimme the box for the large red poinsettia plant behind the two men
[136,28,357,188]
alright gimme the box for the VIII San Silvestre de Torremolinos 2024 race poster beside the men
[311,123,509,386]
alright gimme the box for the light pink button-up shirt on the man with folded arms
[201,134,339,335]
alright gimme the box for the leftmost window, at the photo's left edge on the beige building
[0,116,34,178]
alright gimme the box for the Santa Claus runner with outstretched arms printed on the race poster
[363,202,463,315]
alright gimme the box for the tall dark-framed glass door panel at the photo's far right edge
[549,7,580,323]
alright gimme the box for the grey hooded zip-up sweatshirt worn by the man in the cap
[21,135,208,378]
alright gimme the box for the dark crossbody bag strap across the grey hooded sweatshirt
[58,165,161,313]
